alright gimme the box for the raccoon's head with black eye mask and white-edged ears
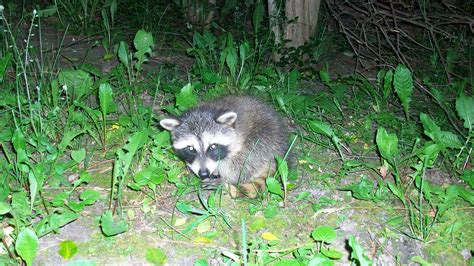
[160,108,238,179]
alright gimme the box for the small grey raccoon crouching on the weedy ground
[160,96,288,198]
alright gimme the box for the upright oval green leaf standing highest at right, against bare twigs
[393,65,413,118]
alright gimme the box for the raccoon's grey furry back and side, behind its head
[205,96,288,183]
